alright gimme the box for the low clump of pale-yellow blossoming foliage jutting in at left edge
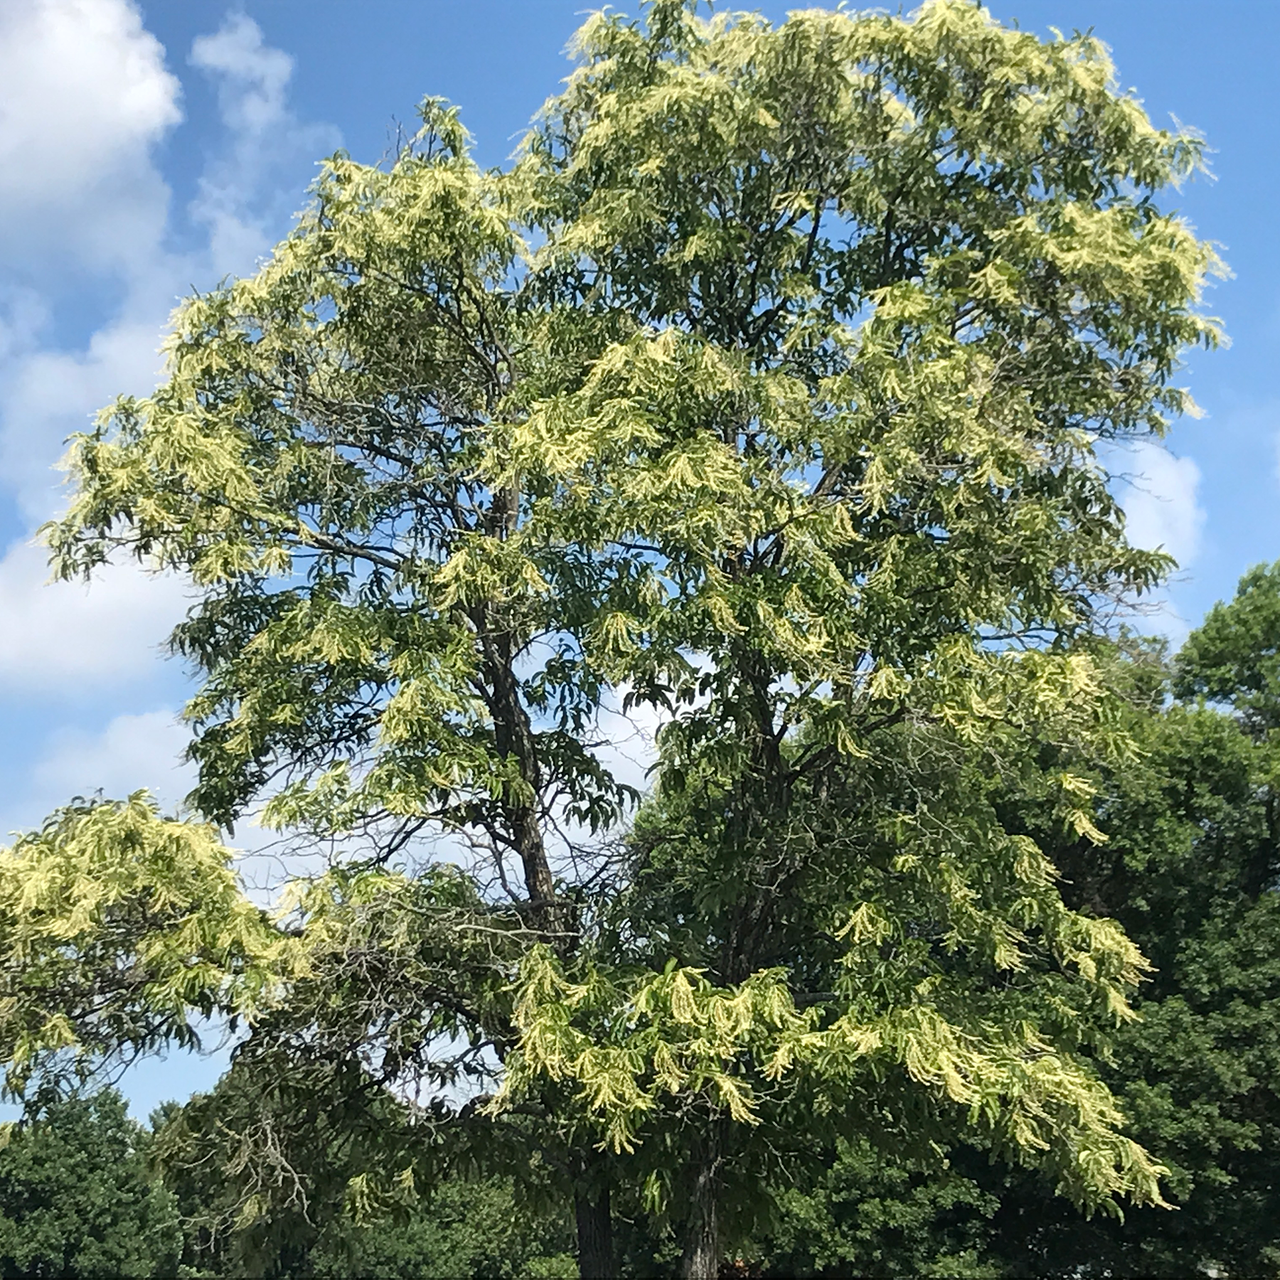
[0,791,291,1088]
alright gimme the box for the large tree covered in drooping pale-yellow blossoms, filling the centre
[0,0,1216,1276]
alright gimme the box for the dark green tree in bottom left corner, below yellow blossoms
[0,1091,182,1280]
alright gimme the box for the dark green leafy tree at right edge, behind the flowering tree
[996,586,1280,1276]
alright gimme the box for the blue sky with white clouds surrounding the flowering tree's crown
[0,0,1280,1110]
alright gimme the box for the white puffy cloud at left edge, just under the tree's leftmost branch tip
[0,543,186,699]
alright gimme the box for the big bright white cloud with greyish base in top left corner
[0,0,182,269]
